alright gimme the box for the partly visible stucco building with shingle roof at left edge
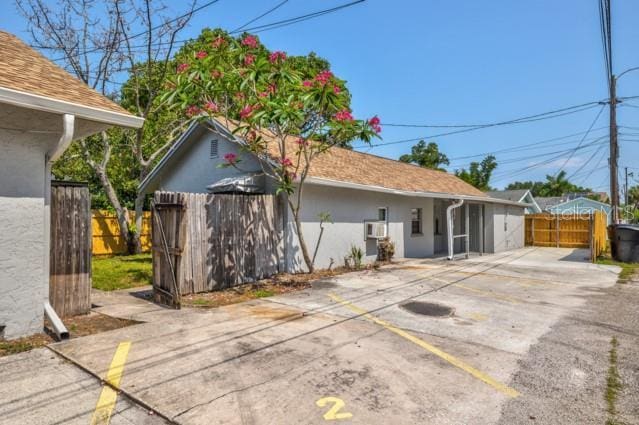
[0,31,143,339]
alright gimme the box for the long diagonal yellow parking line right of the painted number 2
[329,294,520,397]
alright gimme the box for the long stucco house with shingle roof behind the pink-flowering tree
[141,120,528,271]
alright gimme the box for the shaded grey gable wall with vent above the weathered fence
[157,130,261,193]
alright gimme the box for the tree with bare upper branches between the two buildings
[16,0,196,252]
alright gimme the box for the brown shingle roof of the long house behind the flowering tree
[140,120,526,206]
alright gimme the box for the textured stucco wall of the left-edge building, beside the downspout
[0,130,48,339]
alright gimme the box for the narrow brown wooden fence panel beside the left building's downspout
[49,182,91,317]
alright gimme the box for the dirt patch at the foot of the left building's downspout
[0,312,140,357]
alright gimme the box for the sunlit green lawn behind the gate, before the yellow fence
[92,254,153,291]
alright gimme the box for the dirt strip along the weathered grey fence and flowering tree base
[182,267,364,308]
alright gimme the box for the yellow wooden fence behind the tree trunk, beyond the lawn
[91,210,151,255]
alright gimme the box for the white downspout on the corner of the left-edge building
[44,114,75,339]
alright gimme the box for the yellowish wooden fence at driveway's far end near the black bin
[525,211,607,261]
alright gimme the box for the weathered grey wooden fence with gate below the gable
[152,192,283,305]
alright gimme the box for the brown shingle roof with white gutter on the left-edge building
[0,31,144,127]
